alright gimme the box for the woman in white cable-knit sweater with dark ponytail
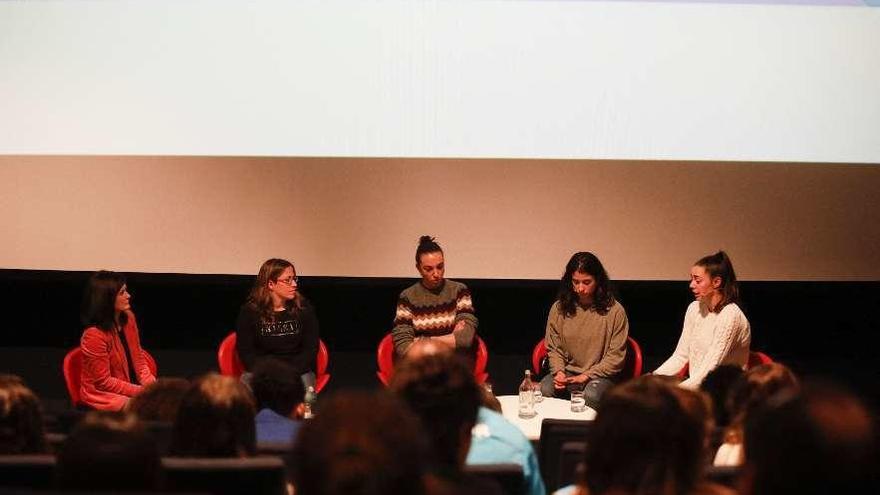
[654,251,752,388]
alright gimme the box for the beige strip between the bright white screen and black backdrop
[0,156,880,280]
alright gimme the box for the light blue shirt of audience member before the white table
[466,407,547,495]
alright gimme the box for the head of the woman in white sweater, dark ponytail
[690,251,739,313]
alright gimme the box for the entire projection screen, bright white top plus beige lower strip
[0,0,880,280]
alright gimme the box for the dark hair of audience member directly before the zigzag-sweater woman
[391,352,481,470]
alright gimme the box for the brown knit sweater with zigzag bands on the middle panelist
[391,280,477,355]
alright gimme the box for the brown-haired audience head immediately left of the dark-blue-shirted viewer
[170,373,256,457]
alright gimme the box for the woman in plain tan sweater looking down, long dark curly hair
[540,252,629,409]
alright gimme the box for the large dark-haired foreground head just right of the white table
[585,377,704,495]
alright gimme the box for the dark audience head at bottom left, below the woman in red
[56,411,162,492]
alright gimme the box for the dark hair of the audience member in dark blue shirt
[251,357,306,417]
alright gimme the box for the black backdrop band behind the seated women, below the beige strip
[0,270,880,408]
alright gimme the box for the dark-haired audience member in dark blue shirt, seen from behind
[251,357,306,446]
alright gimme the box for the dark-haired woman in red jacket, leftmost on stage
[80,270,156,411]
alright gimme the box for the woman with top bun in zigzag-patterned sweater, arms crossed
[391,235,478,356]
